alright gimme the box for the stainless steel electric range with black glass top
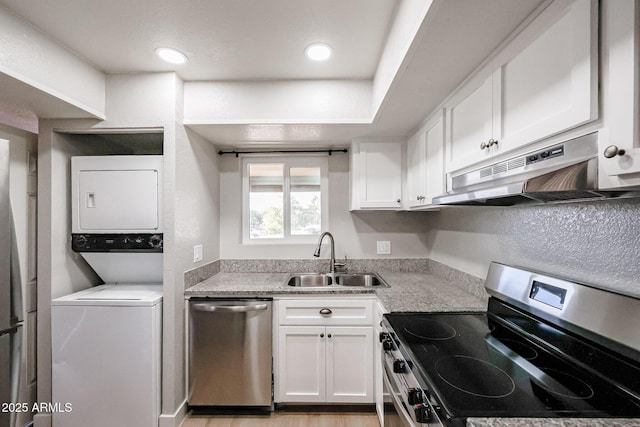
[380,263,640,426]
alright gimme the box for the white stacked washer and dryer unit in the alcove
[51,155,163,427]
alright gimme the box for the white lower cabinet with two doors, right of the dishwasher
[275,300,374,403]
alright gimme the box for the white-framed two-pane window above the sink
[242,157,328,243]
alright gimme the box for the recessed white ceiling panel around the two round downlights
[2,0,397,80]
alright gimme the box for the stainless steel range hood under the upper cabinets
[433,132,640,206]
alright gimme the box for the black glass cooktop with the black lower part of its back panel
[385,300,640,418]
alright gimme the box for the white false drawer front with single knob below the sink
[278,299,373,326]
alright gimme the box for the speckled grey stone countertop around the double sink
[185,271,487,312]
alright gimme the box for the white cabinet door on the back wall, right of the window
[358,142,402,209]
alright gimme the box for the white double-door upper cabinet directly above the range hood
[446,0,598,172]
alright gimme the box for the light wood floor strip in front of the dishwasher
[181,410,380,427]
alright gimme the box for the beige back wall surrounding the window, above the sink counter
[219,154,427,259]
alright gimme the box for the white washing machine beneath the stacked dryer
[51,283,162,427]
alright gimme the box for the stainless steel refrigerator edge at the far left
[0,140,23,427]
